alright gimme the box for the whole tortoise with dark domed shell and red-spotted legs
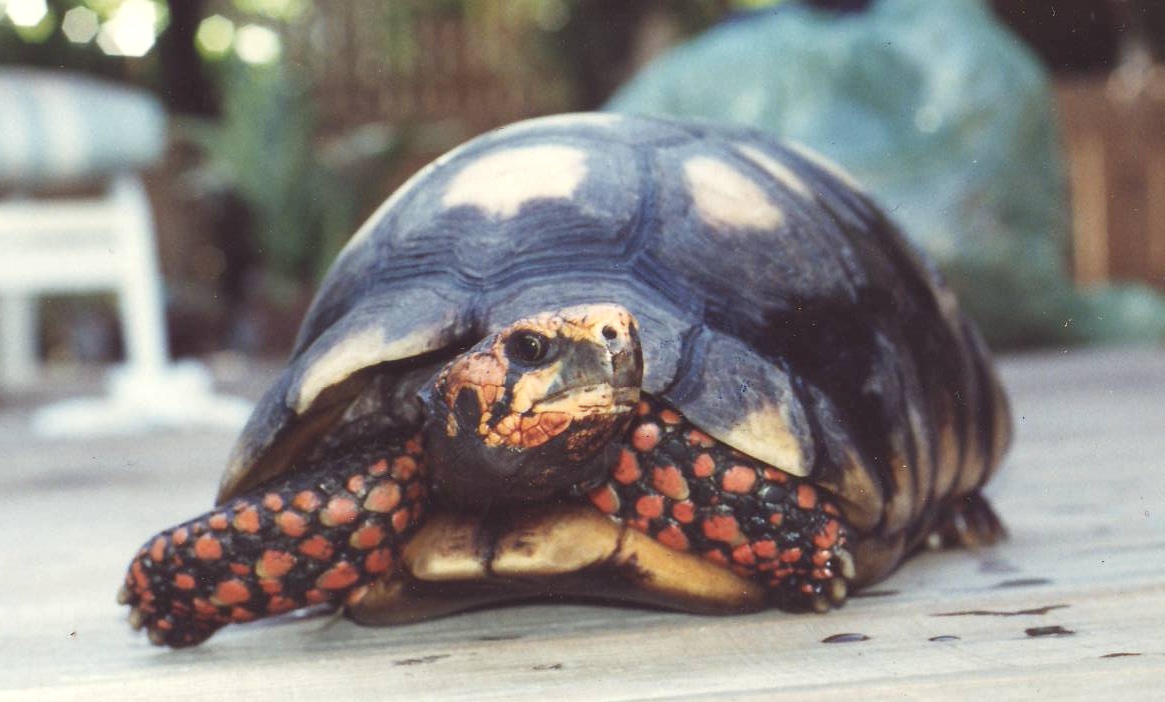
[120,113,1010,647]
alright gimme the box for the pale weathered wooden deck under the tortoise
[0,349,1165,702]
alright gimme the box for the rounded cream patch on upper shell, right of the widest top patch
[684,156,785,229]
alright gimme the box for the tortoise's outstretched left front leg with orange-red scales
[118,438,428,647]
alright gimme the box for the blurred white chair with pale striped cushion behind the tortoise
[0,71,249,435]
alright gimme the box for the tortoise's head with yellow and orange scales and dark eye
[422,305,643,508]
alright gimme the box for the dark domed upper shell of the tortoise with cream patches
[219,114,1009,563]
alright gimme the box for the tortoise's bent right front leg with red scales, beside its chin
[588,397,854,611]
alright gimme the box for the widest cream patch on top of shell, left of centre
[442,146,587,219]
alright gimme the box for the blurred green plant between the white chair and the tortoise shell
[186,65,400,302]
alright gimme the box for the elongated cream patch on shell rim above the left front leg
[295,327,433,414]
